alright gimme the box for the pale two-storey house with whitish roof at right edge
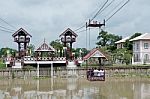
[130,33,150,64]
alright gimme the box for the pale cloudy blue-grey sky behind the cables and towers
[0,0,150,49]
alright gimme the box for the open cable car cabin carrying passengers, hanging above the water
[87,69,105,81]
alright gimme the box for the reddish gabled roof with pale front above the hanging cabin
[83,48,108,60]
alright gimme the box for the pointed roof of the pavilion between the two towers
[35,41,55,52]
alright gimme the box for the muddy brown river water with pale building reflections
[0,78,150,99]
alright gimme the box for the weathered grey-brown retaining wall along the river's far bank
[0,67,150,78]
